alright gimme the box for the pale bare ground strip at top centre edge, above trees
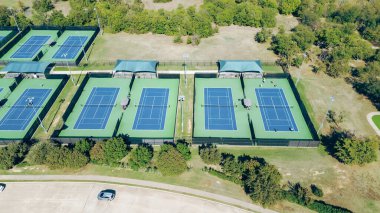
[142,0,203,10]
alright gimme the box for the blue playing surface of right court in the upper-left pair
[53,36,88,59]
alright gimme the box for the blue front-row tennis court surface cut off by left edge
[0,89,52,130]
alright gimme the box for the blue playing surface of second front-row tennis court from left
[74,87,119,129]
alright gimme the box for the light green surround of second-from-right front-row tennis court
[193,78,251,142]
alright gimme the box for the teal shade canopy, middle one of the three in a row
[113,60,158,73]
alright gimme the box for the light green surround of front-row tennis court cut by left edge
[0,79,63,140]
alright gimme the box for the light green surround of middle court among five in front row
[117,79,179,139]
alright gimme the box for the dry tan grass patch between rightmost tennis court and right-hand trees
[291,61,376,136]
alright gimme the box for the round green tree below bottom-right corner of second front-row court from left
[104,137,128,165]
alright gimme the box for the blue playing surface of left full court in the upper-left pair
[11,36,50,58]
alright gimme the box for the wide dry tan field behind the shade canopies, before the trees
[90,26,277,62]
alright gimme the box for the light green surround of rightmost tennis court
[244,78,313,140]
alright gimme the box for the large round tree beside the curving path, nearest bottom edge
[244,163,282,206]
